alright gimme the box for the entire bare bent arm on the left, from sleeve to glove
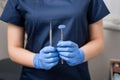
[8,23,34,67]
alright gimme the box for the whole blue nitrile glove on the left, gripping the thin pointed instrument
[33,46,59,70]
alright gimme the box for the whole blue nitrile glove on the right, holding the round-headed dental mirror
[57,41,85,66]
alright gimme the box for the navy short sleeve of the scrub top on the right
[88,0,109,24]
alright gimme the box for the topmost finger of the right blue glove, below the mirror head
[57,41,78,47]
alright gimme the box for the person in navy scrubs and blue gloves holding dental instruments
[0,0,109,80]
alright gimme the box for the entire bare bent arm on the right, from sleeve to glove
[81,20,104,61]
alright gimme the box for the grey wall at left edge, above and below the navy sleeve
[0,0,8,60]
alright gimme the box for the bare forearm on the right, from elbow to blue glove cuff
[81,39,104,61]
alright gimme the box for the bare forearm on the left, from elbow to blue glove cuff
[9,47,35,67]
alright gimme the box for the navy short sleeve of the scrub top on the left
[0,0,24,26]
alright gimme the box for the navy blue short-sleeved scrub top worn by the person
[0,0,109,80]
